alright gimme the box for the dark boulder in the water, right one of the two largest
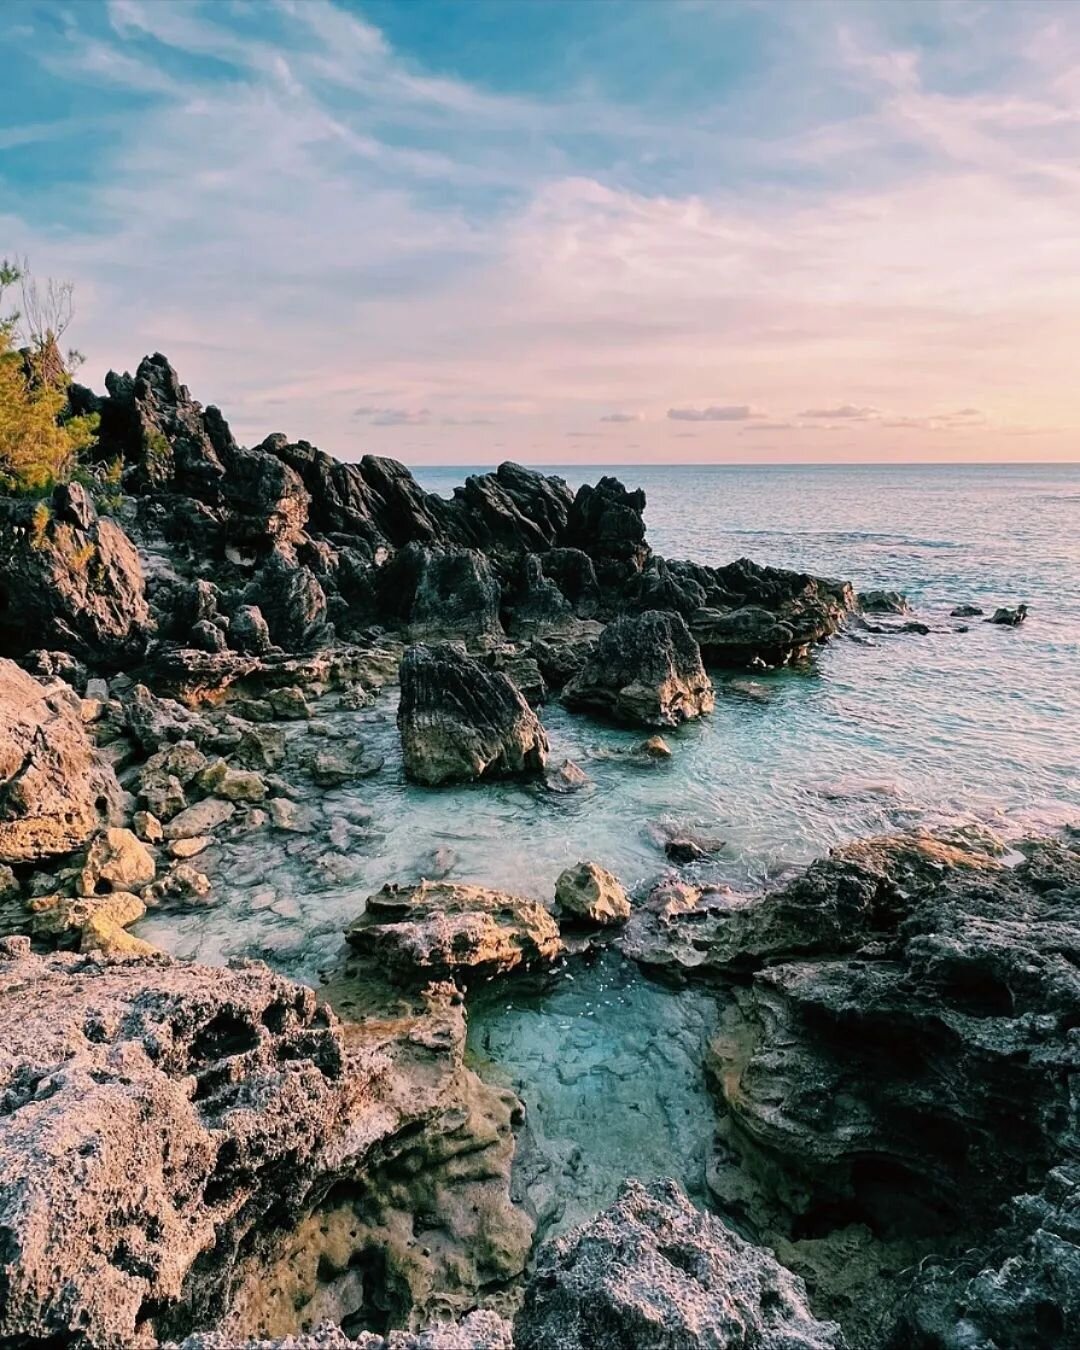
[563,610,716,726]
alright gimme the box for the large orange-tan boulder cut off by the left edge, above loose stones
[0,659,120,864]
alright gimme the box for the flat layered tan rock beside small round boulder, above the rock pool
[346,882,562,981]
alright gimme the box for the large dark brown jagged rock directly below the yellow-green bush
[0,485,153,667]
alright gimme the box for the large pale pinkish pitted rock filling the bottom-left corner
[0,945,361,1346]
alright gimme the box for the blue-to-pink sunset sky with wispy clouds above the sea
[0,0,1080,464]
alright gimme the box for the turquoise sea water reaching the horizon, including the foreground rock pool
[136,466,1080,1223]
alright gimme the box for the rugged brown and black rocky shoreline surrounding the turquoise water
[0,355,1080,1350]
